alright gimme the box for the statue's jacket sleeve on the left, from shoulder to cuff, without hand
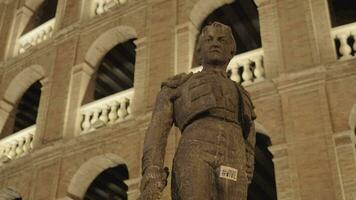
[142,86,174,173]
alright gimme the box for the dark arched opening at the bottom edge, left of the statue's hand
[84,164,129,200]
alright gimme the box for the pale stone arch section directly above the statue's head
[189,0,234,29]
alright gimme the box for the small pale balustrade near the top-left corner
[18,18,56,54]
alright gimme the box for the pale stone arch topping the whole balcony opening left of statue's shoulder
[85,26,137,68]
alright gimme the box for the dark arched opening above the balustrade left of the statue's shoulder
[83,39,136,104]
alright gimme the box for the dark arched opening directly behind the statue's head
[192,0,262,67]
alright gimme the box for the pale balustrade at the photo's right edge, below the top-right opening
[331,23,356,59]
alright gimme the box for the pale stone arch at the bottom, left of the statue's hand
[68,153,126,199]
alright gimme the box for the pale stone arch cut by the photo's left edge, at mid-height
[0,64,46,133]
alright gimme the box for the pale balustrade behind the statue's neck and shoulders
[191,48,265,85]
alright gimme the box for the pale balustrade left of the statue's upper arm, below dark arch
[80,88,134,133]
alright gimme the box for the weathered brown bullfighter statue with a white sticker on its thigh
[140,22,256,200]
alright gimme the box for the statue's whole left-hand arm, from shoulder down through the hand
[141,87,174,200]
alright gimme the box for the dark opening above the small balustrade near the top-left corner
[21,0,58,35]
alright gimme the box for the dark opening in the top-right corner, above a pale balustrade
[328,0,356,27]
